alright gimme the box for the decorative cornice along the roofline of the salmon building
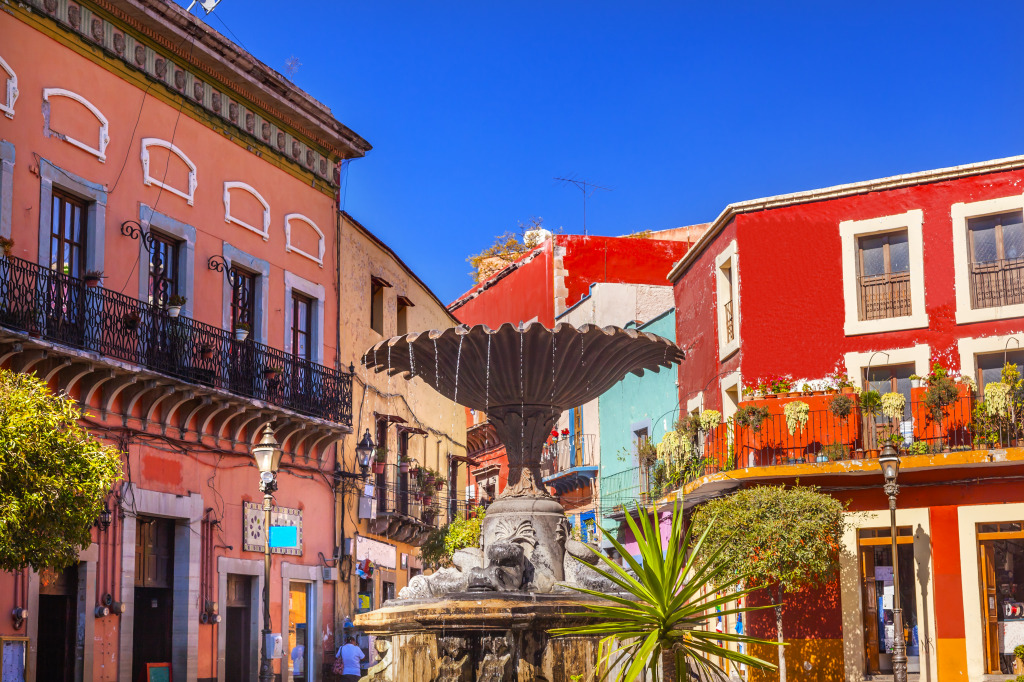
[16,0,371,187]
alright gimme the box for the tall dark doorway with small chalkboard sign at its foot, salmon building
[132,516,174,680]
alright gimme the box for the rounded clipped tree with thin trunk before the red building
[693,485,846,682]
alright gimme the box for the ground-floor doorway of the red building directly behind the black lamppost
[858,526,921,674]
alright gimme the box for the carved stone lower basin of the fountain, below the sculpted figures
[355,592,598,682]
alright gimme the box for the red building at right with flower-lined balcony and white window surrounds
[670,157,1024,682]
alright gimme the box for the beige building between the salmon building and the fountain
[336,212,467,634]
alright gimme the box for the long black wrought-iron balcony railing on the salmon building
[0,256,352,426]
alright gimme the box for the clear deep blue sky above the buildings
[182,0,1024,302]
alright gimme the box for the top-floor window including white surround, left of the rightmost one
[839,209,928,336]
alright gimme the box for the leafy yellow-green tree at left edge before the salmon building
[0,370,121,570]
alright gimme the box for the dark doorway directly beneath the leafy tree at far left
[36,565,78,682]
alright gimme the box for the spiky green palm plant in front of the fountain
[551,503,776,682]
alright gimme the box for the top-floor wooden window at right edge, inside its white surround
[967,211,1024,308]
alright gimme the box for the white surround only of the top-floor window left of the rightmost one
[839,209,928,336]
